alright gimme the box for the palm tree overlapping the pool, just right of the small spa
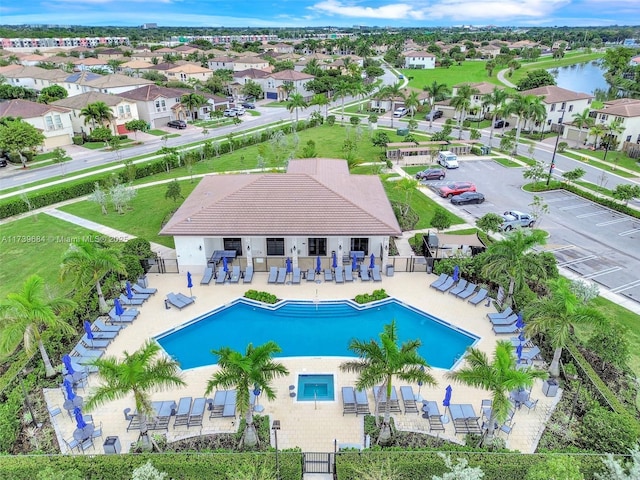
[340,320,436,444]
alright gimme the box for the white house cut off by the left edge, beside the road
[0,100,73,150]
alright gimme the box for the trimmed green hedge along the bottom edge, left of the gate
[0,452,302,480]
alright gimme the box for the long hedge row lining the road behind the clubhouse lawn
[0,122,316,218]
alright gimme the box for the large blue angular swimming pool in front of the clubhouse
[156,299,478,369]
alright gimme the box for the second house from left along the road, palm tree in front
[52,91,139,134]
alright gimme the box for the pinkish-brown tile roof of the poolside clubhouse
[160,159,401,236]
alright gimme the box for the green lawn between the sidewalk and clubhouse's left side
[60,179,199,248]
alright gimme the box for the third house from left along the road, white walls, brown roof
[119,84,189,128]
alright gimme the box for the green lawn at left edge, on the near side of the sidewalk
[0,214,101,298]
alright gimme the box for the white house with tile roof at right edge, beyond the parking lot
[590,98,640,151]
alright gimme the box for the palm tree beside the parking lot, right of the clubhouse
[482,229,546,308]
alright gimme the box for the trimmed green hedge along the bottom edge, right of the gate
[336,451,605,480]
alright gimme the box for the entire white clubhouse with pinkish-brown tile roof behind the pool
[160,158,402,273]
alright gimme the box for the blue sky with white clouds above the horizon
[0,0,640,28]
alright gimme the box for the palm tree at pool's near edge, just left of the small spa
[205,341,289,447]
